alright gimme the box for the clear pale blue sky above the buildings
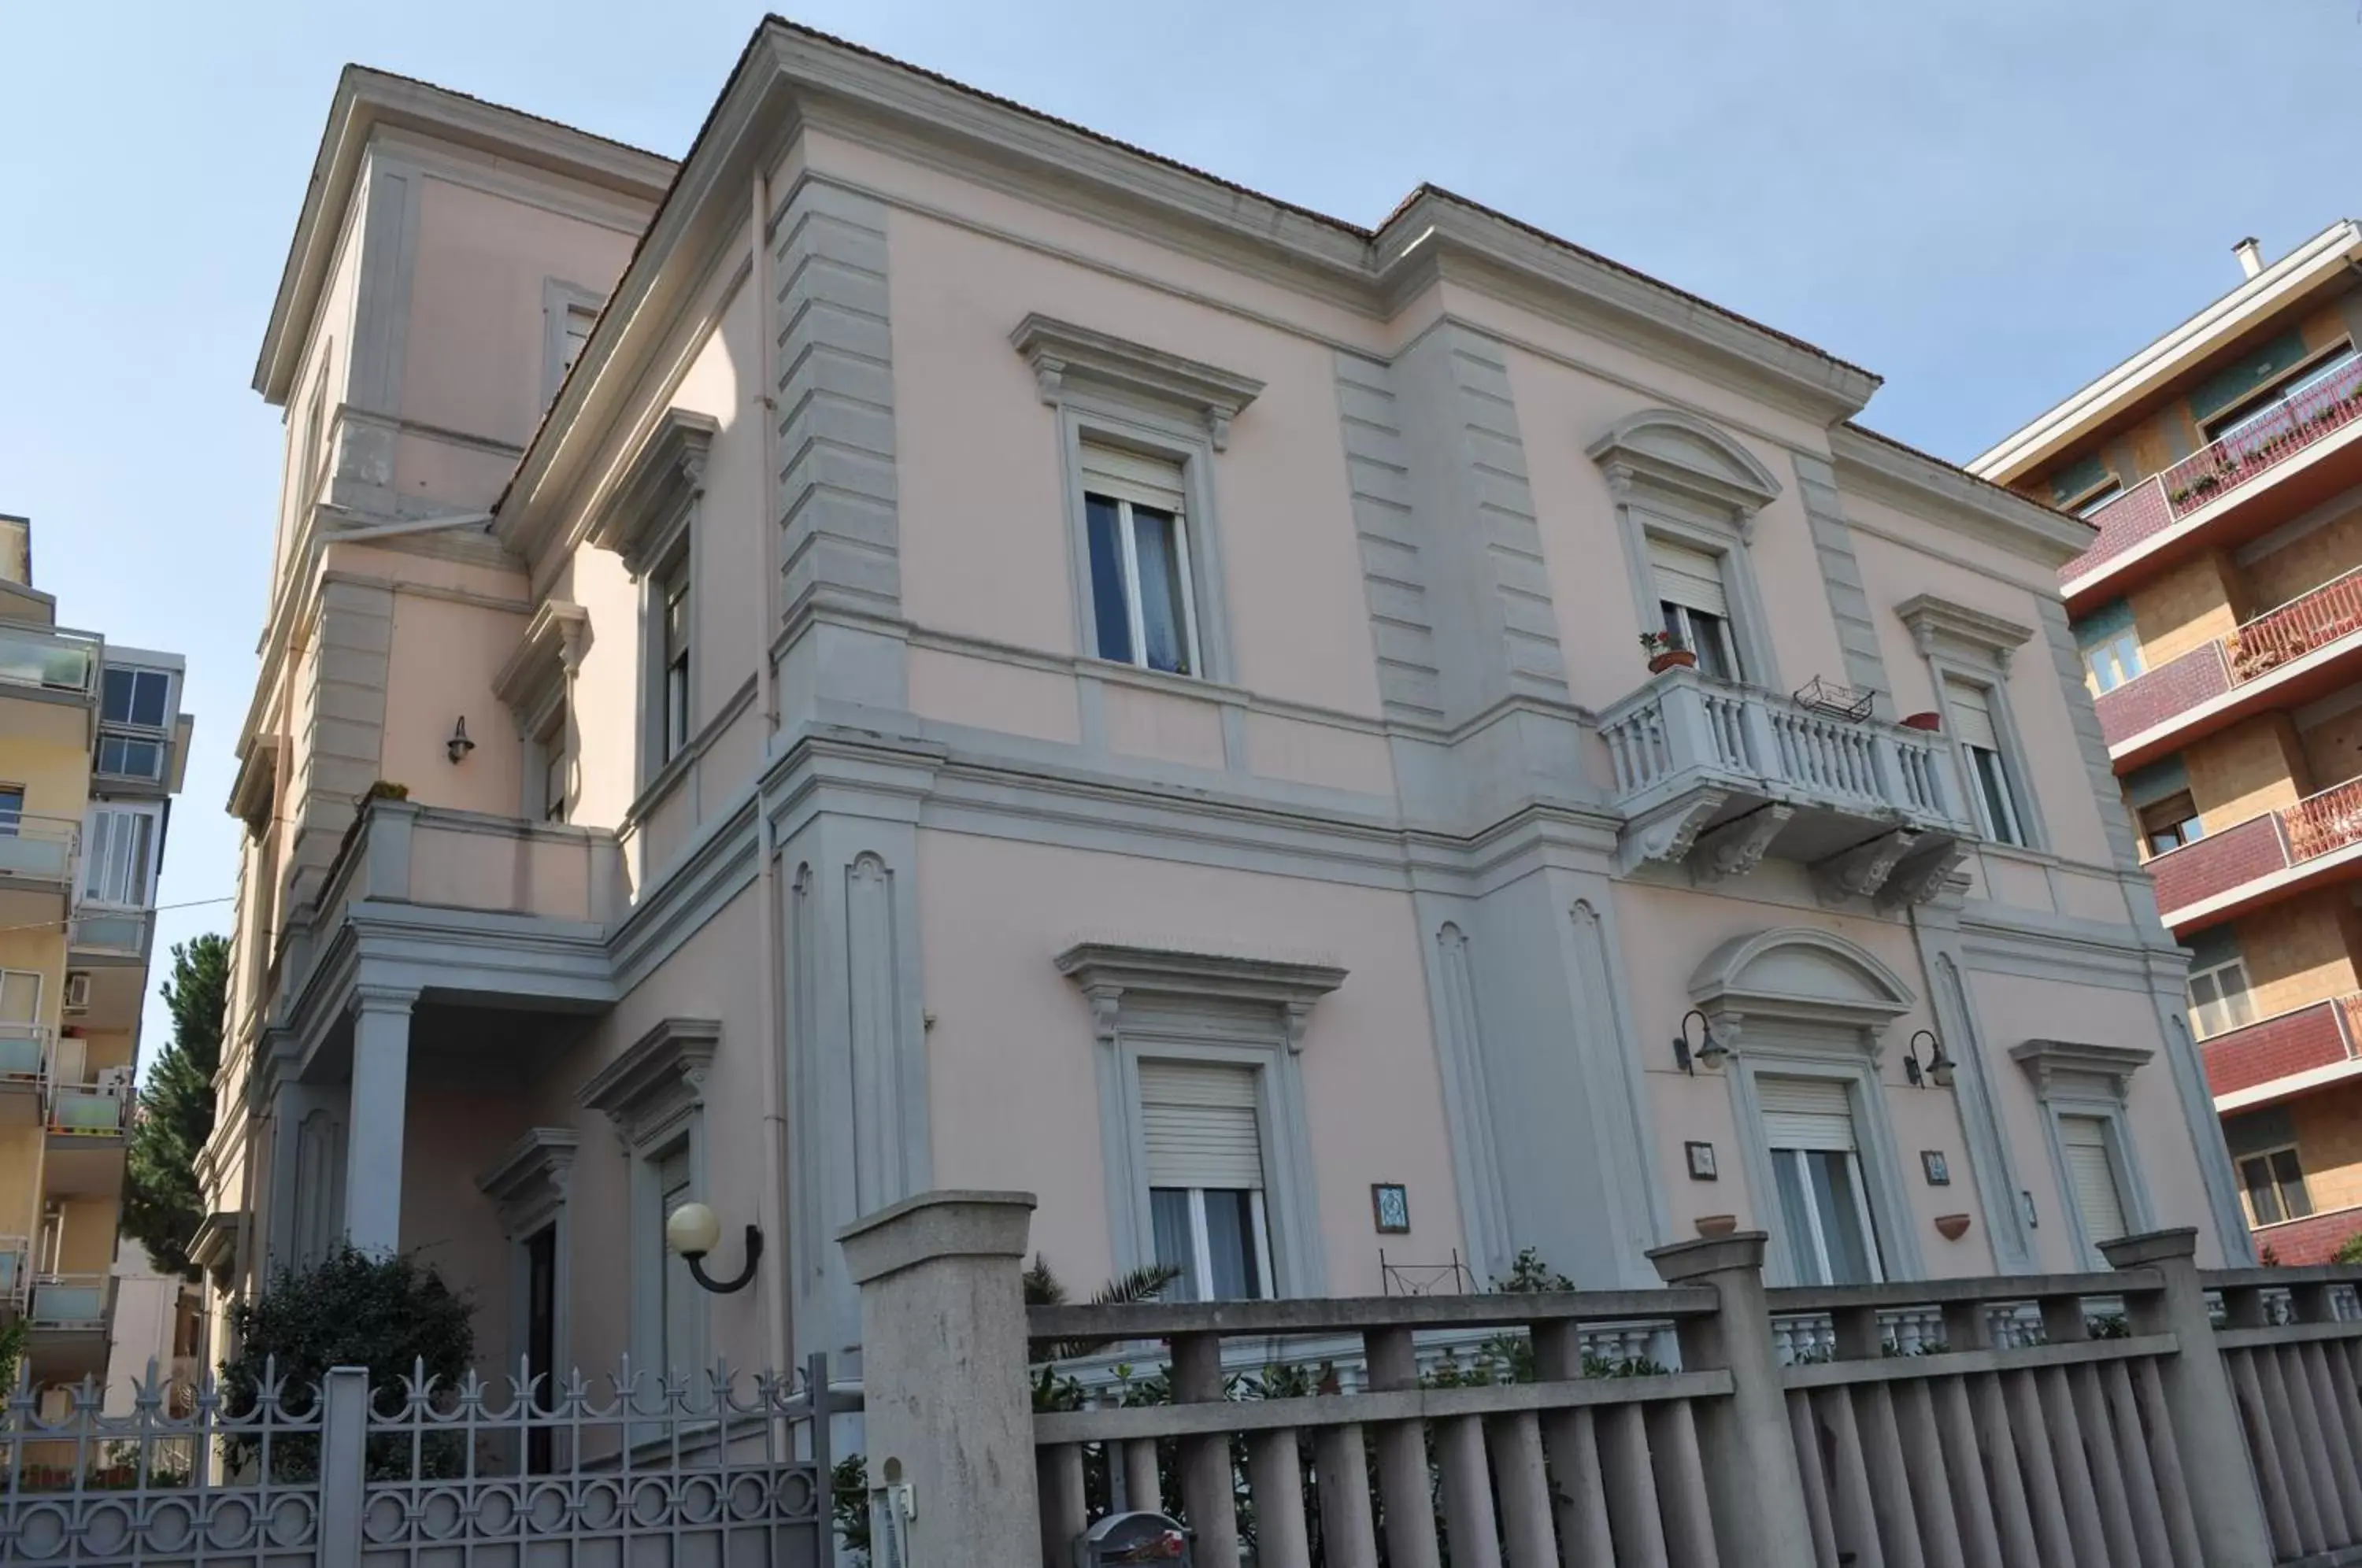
[0,0,2362,1058]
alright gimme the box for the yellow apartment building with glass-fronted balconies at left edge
[0,517,191,1398]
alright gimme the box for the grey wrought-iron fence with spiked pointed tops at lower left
[0,1358,860,1568]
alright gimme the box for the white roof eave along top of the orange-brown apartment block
[1968,217,2362,484]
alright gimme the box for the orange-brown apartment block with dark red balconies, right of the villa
[1970,222,2362,1263]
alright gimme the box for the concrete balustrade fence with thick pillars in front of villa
[848,1195,2362,1568]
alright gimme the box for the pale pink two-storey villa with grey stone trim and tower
[198,21,2251,1367]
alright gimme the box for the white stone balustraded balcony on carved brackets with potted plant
[1599,668,1977,909]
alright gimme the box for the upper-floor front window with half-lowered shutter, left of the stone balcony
[1082,442,1205,675]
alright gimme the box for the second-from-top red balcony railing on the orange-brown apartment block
[2093,567,2362,756]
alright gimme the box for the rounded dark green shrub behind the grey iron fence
[222,1242,475,1478]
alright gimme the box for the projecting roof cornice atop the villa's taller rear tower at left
[253,66,673,404]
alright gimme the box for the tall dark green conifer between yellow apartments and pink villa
[123,935,229,1280]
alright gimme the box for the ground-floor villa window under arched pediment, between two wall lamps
[1755,1077,1885,1285]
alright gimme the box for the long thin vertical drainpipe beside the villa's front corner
[746,168,794,1398]
